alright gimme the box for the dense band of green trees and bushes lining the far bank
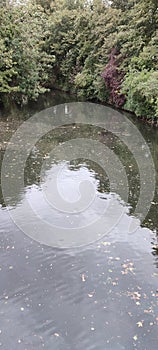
[0,0,158,119]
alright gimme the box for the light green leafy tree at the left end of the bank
[0,3,53,102]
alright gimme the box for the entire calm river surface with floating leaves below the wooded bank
[0,92,158,350]
